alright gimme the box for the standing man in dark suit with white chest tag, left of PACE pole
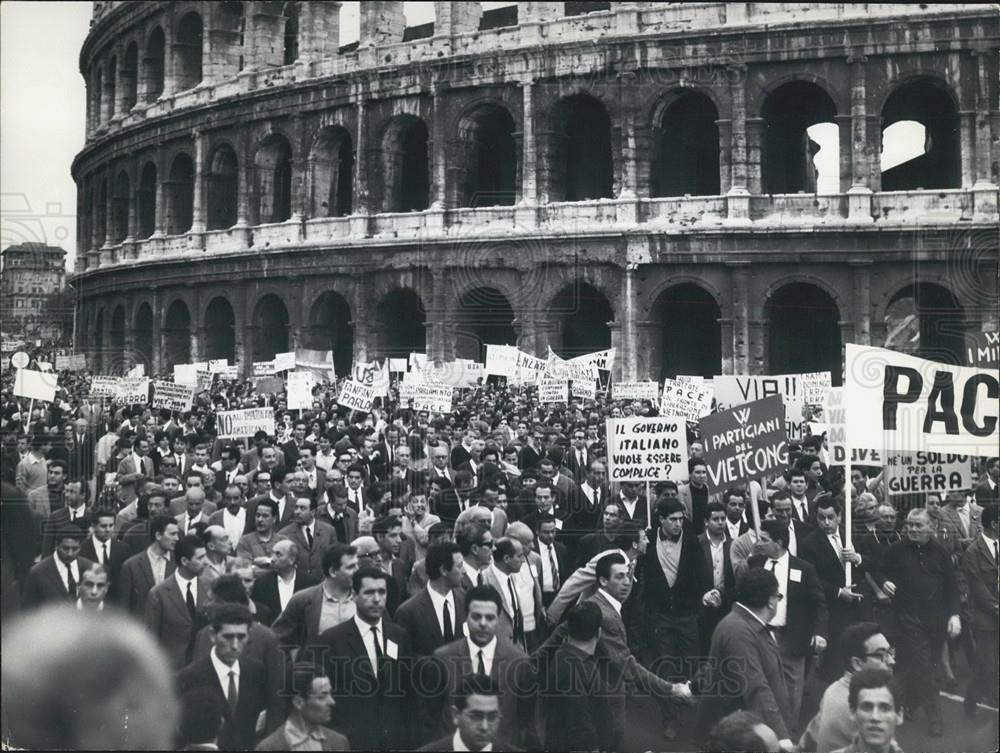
[749,520,828,730]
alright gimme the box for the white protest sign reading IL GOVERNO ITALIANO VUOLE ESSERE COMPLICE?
[606,416,688,482]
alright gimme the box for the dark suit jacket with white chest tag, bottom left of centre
[317,619,416,750]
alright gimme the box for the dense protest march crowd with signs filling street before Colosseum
[0,346,1000,753]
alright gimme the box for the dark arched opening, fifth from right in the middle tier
[455,104,520,207]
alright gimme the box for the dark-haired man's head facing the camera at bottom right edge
[834,669,903,753]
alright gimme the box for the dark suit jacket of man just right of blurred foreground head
[175,656,268,750]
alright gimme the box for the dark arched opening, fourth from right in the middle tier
[543,94,614,201]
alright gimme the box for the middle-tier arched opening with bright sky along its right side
[761,81,839,193]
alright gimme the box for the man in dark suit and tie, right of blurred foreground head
[175,604,271,750]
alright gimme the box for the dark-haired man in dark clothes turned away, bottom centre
[542,601,613,751]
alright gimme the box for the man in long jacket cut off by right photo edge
[962,505,1000,717]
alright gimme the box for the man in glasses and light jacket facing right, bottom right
[799,622,896,753]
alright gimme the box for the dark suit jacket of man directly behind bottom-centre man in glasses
[432,636,537,750]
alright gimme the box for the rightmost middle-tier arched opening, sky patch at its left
[882,78,962,191]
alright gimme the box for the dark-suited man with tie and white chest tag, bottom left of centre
[317,567,415,750]
